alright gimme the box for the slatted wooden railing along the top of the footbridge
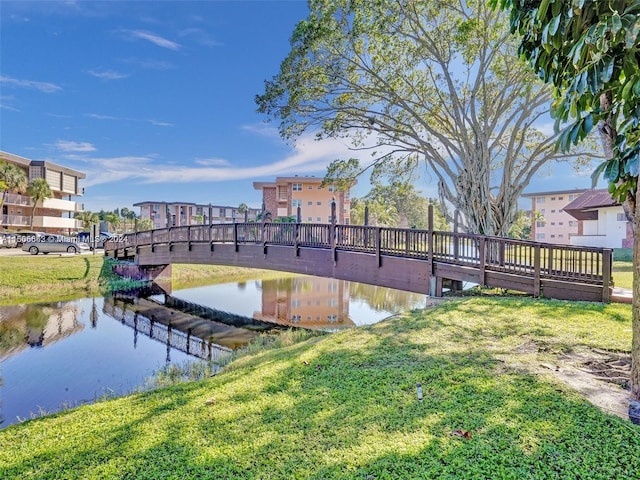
[105,223,611,284]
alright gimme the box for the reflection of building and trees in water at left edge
[0,302,84,357]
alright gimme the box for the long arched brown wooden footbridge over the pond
[105,218,613,302]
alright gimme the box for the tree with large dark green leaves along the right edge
[496,0,640,410]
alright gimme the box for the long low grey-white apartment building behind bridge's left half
[133,201,260,228]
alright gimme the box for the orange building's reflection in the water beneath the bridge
[253,277,354,329]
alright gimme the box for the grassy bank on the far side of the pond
[0,255,276,305]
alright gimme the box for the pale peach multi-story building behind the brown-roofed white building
[522,189,587,245]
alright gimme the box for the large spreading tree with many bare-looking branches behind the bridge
[256,0,596,235]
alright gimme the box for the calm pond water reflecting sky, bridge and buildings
[0,276,426,428]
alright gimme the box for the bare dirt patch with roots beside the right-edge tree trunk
[513,342,631,419]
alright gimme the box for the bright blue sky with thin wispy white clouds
[0,0,604,211]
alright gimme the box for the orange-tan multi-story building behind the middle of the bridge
[253,175,351,225]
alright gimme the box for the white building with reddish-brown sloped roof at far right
[564,189,633,248]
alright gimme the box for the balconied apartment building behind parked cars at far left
[0,151,86,233]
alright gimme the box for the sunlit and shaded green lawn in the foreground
[0,298,640,480]
